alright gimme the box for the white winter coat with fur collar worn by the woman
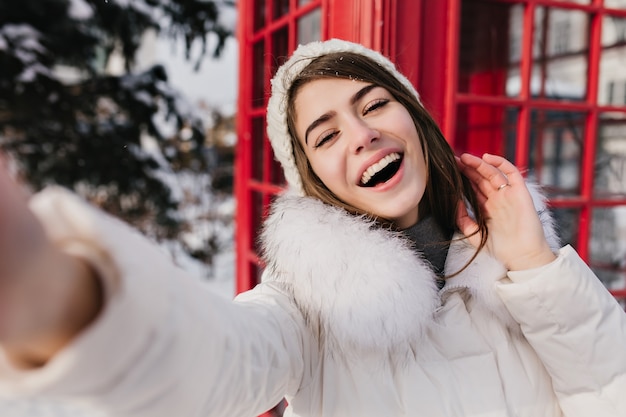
[0,189,626,417]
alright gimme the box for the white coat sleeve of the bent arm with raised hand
[498,246,626,417]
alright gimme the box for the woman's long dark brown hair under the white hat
[287,52,487,273]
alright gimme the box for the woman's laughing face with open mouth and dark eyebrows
[294,78,427,228]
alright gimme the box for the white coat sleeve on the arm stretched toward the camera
[0,189,312,417]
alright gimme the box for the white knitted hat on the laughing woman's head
[267,39,419,196]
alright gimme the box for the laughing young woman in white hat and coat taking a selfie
[0,40,626,417]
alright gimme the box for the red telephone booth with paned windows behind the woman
[236,0,626,308]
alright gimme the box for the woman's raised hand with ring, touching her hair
[457,154,555,271]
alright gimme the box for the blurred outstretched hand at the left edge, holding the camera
[0,155,102,368]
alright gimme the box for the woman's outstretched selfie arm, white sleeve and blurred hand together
[0,158,308,417]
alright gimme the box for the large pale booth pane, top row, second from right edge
[530,7,589,101]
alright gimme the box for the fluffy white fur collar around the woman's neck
[261,187,558,352]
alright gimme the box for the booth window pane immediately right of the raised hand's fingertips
[528,110,585,197]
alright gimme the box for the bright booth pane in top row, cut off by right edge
[598,15,626,106]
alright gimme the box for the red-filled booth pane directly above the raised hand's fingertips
[454,104,518,160]
